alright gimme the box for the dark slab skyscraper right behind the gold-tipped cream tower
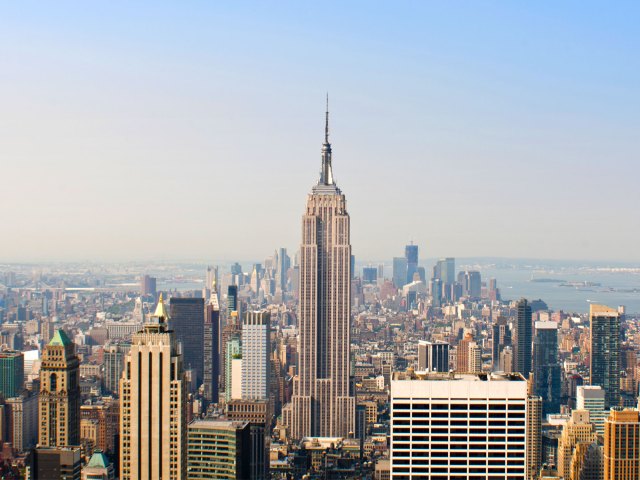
[168,297,205,388]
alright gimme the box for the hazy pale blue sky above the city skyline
[0,1,640,261]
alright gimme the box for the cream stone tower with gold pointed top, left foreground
[120,294,187,480]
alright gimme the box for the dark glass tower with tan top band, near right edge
[589,304,620,408]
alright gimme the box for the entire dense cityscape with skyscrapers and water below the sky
[0,111,640,480]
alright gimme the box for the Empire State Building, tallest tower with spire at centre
[283,104,355,439]
